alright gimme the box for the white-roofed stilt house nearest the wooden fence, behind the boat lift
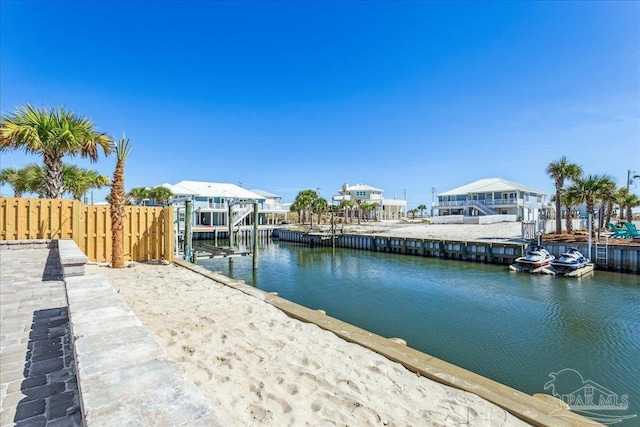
[163,181,290,227]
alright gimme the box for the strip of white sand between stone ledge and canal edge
[87,226,527,426]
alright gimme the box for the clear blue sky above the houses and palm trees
[0,0,640,208]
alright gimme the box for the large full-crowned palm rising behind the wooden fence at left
[0,104,114,199]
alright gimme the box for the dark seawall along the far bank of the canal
[274,229,640,274]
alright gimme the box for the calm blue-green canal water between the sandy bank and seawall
[199,242,640,425]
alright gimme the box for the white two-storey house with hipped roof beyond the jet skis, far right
[431,178,552,222]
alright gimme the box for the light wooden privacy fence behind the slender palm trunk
[0,198,174,262]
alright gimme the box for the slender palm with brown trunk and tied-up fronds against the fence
[109,137,131,268]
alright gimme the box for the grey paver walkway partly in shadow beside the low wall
[0,243,82,427]
